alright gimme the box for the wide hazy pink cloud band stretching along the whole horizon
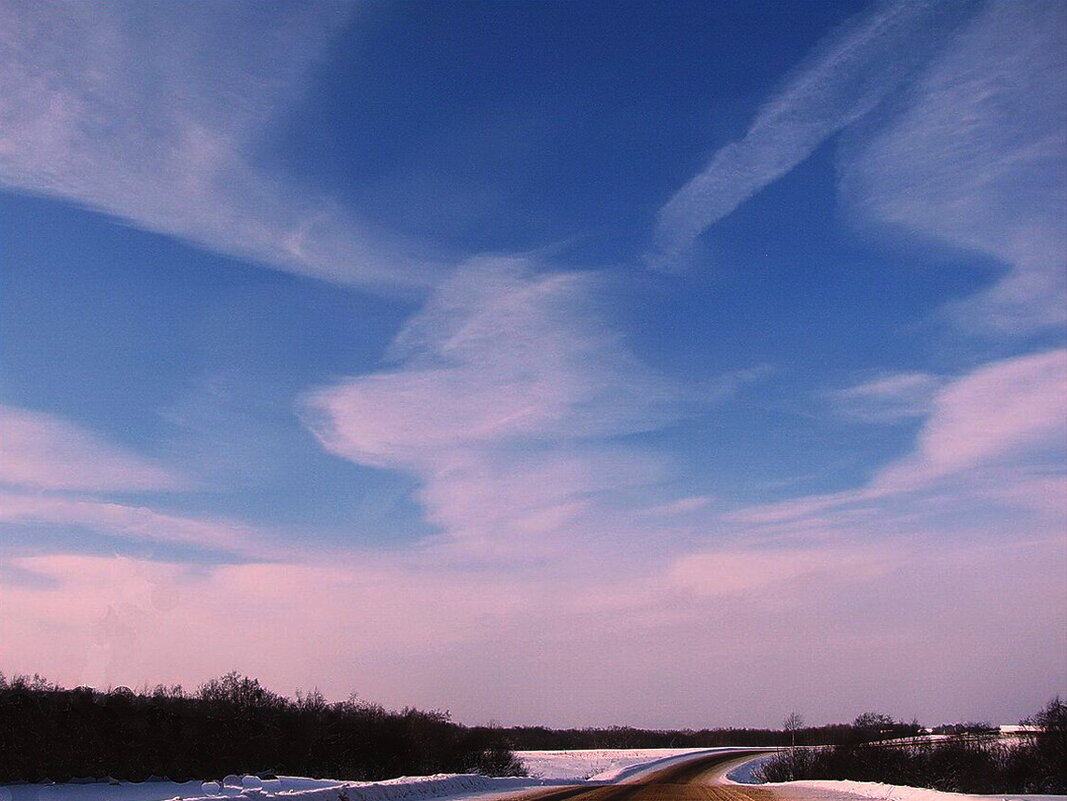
[3,540,1067,726]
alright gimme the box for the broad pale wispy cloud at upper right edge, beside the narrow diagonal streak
[841,0,1067,334]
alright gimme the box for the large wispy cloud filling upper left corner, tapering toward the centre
[0,0,436,293]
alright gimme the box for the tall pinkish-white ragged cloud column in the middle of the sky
[303,258,680,558]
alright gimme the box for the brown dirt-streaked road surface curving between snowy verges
[510,751,858,801]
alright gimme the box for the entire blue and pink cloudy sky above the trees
[0,0,1067,727]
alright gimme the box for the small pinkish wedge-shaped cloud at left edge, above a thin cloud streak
[0,406,185,492]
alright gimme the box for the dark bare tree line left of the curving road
[0,673,524,782]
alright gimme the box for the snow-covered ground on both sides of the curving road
[0,749,1067,801]
